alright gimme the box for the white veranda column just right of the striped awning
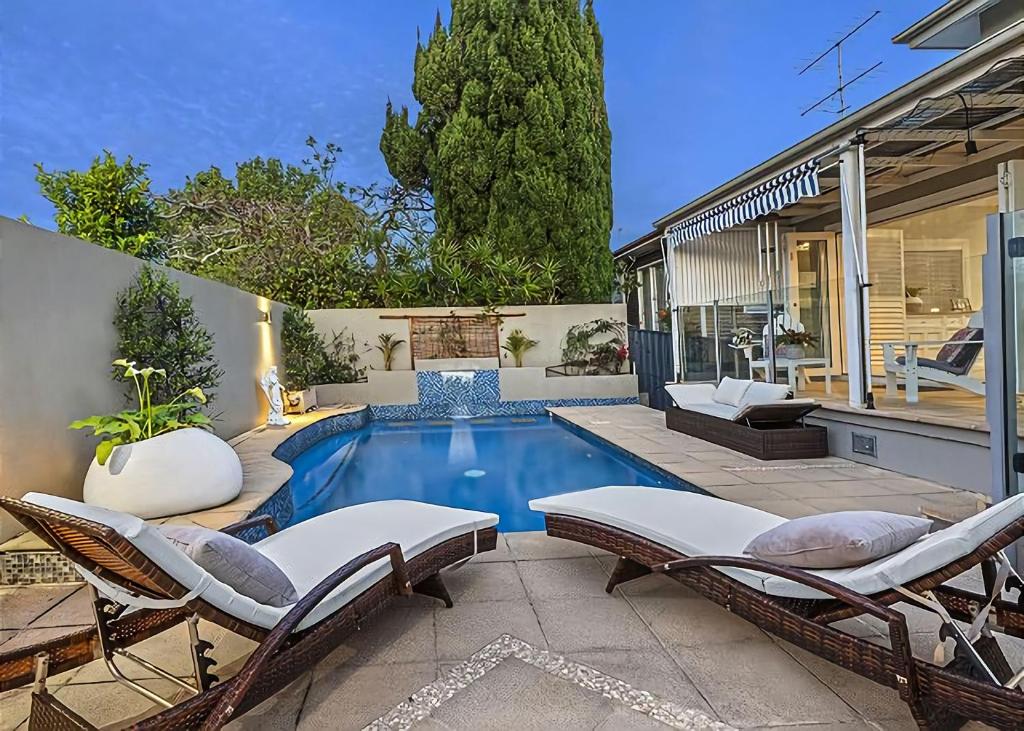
[840,143,871,406]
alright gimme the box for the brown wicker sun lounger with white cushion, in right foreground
[530,487,1024,730]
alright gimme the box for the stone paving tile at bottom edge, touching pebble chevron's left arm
[297,661,437,731]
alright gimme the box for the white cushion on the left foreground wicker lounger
[23,492,498,630]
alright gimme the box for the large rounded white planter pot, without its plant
[83,429,242,518]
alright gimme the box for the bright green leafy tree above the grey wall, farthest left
[36,151,162,259]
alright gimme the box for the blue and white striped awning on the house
[667,160,820,246]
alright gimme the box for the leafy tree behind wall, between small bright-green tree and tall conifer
[160,137,374,308]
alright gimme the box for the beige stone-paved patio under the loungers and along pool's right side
[0,406,1003,731]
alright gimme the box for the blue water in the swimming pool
[291,417,692,531]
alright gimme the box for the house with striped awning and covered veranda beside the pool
[615,0,1024,495]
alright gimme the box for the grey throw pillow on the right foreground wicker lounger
[743,510,932,568]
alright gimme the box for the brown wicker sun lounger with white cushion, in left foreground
[0,493,498,730]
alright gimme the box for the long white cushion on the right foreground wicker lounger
[529,486,1024,599]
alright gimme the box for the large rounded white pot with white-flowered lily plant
[70,358,242,518]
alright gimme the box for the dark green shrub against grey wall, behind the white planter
[114,266,224,403]
